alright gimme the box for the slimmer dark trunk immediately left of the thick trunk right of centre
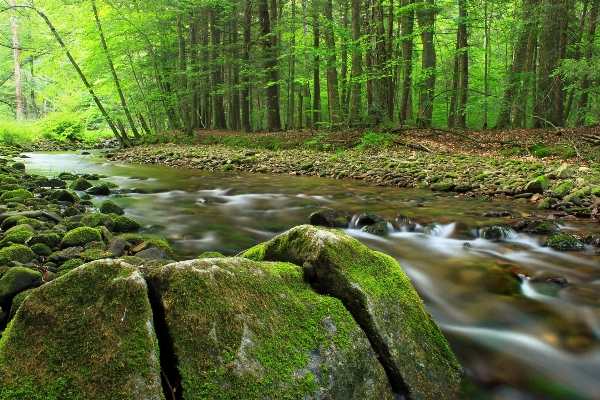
[398,0,415,125]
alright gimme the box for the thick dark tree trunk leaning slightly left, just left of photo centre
[258,0,281,132]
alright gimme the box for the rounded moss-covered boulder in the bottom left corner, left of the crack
[0,260,164,400]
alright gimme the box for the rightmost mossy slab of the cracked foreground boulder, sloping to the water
[242,225,464,399]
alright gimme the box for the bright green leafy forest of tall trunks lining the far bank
[0,0,600,142]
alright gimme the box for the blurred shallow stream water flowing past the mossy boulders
[23,153,600,399]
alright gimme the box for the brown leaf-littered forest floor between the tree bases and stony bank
[154,125,600,163]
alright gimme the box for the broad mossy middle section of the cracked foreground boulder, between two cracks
[147,258,393,400]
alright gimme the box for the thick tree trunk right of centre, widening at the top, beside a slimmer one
[417,0,437,128]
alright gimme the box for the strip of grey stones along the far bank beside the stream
[107,144,600,222]
